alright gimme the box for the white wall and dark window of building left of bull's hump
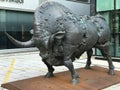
[0,0,39,49]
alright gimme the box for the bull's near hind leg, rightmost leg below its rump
[99,42,114,75]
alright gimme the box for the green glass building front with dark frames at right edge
[96,0,120,57]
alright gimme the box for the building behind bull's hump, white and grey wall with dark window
[0,0,92,50]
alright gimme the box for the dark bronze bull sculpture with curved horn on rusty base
[6,2,114,84]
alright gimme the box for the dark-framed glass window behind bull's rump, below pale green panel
[96,10,120,57]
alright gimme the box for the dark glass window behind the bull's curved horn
[0,10,33,49]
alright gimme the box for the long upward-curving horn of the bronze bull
[5,32,34,47]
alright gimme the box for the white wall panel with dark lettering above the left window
[0,0,39,11]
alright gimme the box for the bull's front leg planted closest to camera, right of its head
[64,58,79,84]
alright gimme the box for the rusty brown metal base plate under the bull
[2,66,120,90]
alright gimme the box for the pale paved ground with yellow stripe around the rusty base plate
[0,51,120,90]
